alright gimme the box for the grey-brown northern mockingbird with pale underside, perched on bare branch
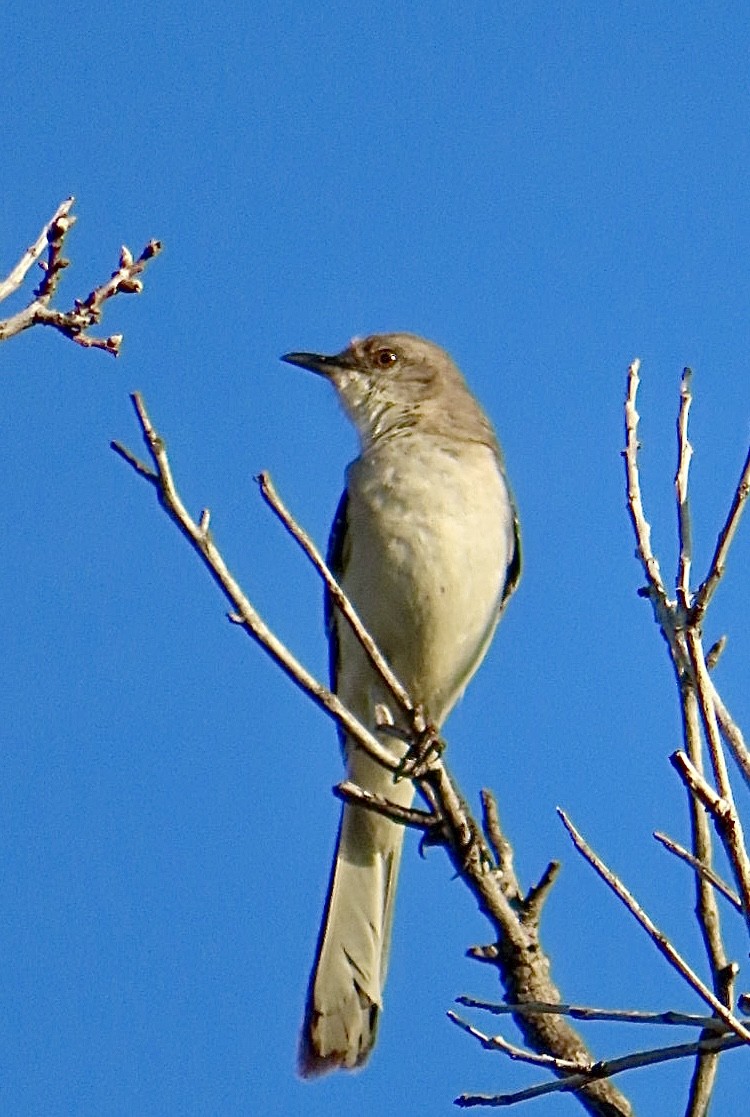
[283,334,520,1077]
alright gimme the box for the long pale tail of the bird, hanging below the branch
[298,795,411,1078]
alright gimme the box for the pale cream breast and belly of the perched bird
[340,437,514,722]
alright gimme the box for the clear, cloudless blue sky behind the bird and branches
[0,0,750,1117]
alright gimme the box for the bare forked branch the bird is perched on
[113,394,632,1117]
